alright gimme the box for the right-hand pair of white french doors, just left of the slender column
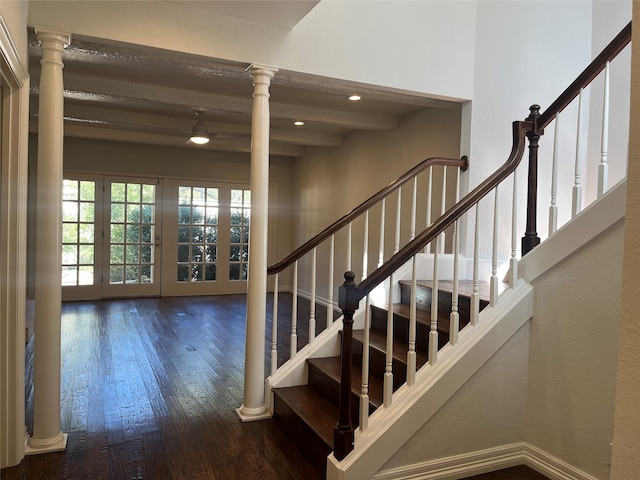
[162,181,251,296]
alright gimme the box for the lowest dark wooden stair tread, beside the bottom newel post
[273,385,338,448]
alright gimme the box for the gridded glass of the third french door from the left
[176,186,219,283]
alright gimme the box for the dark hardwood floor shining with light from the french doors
[0,295,544,480]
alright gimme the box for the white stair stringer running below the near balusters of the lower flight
[326,280,533,480]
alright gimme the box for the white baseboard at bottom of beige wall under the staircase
[372,442,597,480]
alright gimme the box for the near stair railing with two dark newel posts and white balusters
[334,24,631,461]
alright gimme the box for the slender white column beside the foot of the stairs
[237,65,278,422]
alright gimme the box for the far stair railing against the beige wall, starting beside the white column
[267,156,469,375]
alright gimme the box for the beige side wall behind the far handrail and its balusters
[292,109,462,299]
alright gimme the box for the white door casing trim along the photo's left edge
[0,11,29,468]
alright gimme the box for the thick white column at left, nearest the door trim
[27,27,71,454]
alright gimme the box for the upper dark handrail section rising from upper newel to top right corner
[536,22,631,130]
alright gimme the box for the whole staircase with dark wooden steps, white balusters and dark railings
[265,24,631,480]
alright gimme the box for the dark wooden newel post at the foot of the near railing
[333,271,360,460]
